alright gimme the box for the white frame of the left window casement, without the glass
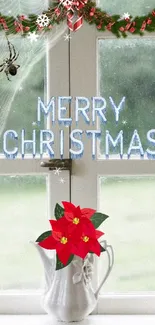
[0,39,70,314]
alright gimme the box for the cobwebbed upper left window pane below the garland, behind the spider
[0,36,46,153]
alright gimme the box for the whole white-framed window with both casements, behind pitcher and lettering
[0,0,155,314]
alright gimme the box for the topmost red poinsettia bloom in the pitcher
[62,201,96,229]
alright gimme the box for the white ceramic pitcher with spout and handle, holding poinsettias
[34,241,114,322]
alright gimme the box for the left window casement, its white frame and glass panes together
[0,1,70,314]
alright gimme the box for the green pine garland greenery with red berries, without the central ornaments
[0,0,155,37]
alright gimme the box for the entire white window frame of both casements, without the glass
[0,4,155,314]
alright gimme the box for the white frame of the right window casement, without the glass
[70,23,155,314]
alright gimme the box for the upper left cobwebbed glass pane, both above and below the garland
[0,0,49,154]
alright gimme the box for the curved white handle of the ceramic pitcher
[95,240,114,298]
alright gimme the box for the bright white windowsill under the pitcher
[0,315,155,325]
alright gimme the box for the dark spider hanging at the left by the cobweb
[0,38,20,81]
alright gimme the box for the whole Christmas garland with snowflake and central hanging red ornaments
[0,0,155,37]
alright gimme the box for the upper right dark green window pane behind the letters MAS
[98,39,155,158]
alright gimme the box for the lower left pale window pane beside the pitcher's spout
[0,176,49,290]
